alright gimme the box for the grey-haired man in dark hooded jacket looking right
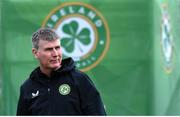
[17,28,106,115]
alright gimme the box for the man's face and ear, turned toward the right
[32,39,62,70]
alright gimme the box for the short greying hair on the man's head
[32,28,59,49]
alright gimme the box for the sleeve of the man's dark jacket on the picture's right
[79,74,106,115]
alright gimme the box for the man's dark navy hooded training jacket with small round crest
[17,58,106,115]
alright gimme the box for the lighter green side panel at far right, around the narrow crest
[151,0,180,115]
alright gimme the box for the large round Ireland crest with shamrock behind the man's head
[42,2,110,71]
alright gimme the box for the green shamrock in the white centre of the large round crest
[61,21,91,53]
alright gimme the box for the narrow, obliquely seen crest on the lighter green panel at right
[161,4,174,73]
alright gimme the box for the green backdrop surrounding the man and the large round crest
[0,0,180,115]
